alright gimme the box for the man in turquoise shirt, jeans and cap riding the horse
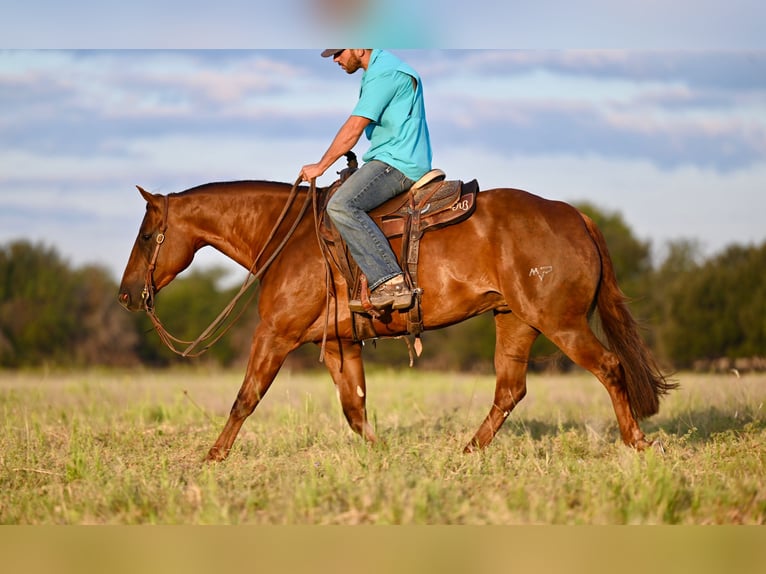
[301,48,431,310]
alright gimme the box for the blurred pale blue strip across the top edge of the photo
[0,0,766,49]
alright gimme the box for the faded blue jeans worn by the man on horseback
[327,160,414,291]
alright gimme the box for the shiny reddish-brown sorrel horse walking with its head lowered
[119,181,676,460]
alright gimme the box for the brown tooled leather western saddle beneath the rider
[317,170,479,341]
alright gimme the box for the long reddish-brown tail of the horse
[581,213,678,420]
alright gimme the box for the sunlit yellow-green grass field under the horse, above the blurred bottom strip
[0,368,766,525]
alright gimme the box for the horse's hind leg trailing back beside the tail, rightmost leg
[545,318,649,450]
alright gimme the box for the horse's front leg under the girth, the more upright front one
[325,341,376,442]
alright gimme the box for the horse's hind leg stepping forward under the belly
[465,313,539,452]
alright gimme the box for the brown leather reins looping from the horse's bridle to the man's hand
[141,177,316,357]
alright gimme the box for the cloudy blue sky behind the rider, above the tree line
[0,0,766,280]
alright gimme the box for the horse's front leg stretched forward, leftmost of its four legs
[205,323,298,461]
